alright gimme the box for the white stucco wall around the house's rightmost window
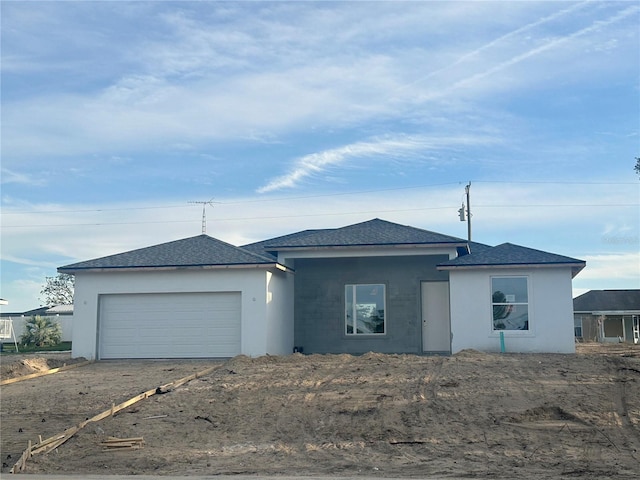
[450,268,575,353]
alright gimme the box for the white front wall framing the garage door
[72,269,276,360]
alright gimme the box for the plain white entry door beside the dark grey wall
[421,282,451,353]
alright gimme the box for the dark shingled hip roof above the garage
[58,234,275,273]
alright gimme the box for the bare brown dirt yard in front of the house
[0,345,640,479]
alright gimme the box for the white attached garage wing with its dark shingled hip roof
[59,235,294,360]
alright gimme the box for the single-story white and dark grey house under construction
[58,219,585,359]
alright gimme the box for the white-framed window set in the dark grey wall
[344,284,385,335]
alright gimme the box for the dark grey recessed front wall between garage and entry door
[294,254,449,354]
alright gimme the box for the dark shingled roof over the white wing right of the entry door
[438,243,586,276]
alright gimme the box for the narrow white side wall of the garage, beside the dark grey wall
[266,272,295,355]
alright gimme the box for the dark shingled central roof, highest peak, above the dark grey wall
[261,218,467,251]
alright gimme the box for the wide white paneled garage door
[98,292,240,359]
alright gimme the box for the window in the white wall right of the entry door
[491,277,529,331]
